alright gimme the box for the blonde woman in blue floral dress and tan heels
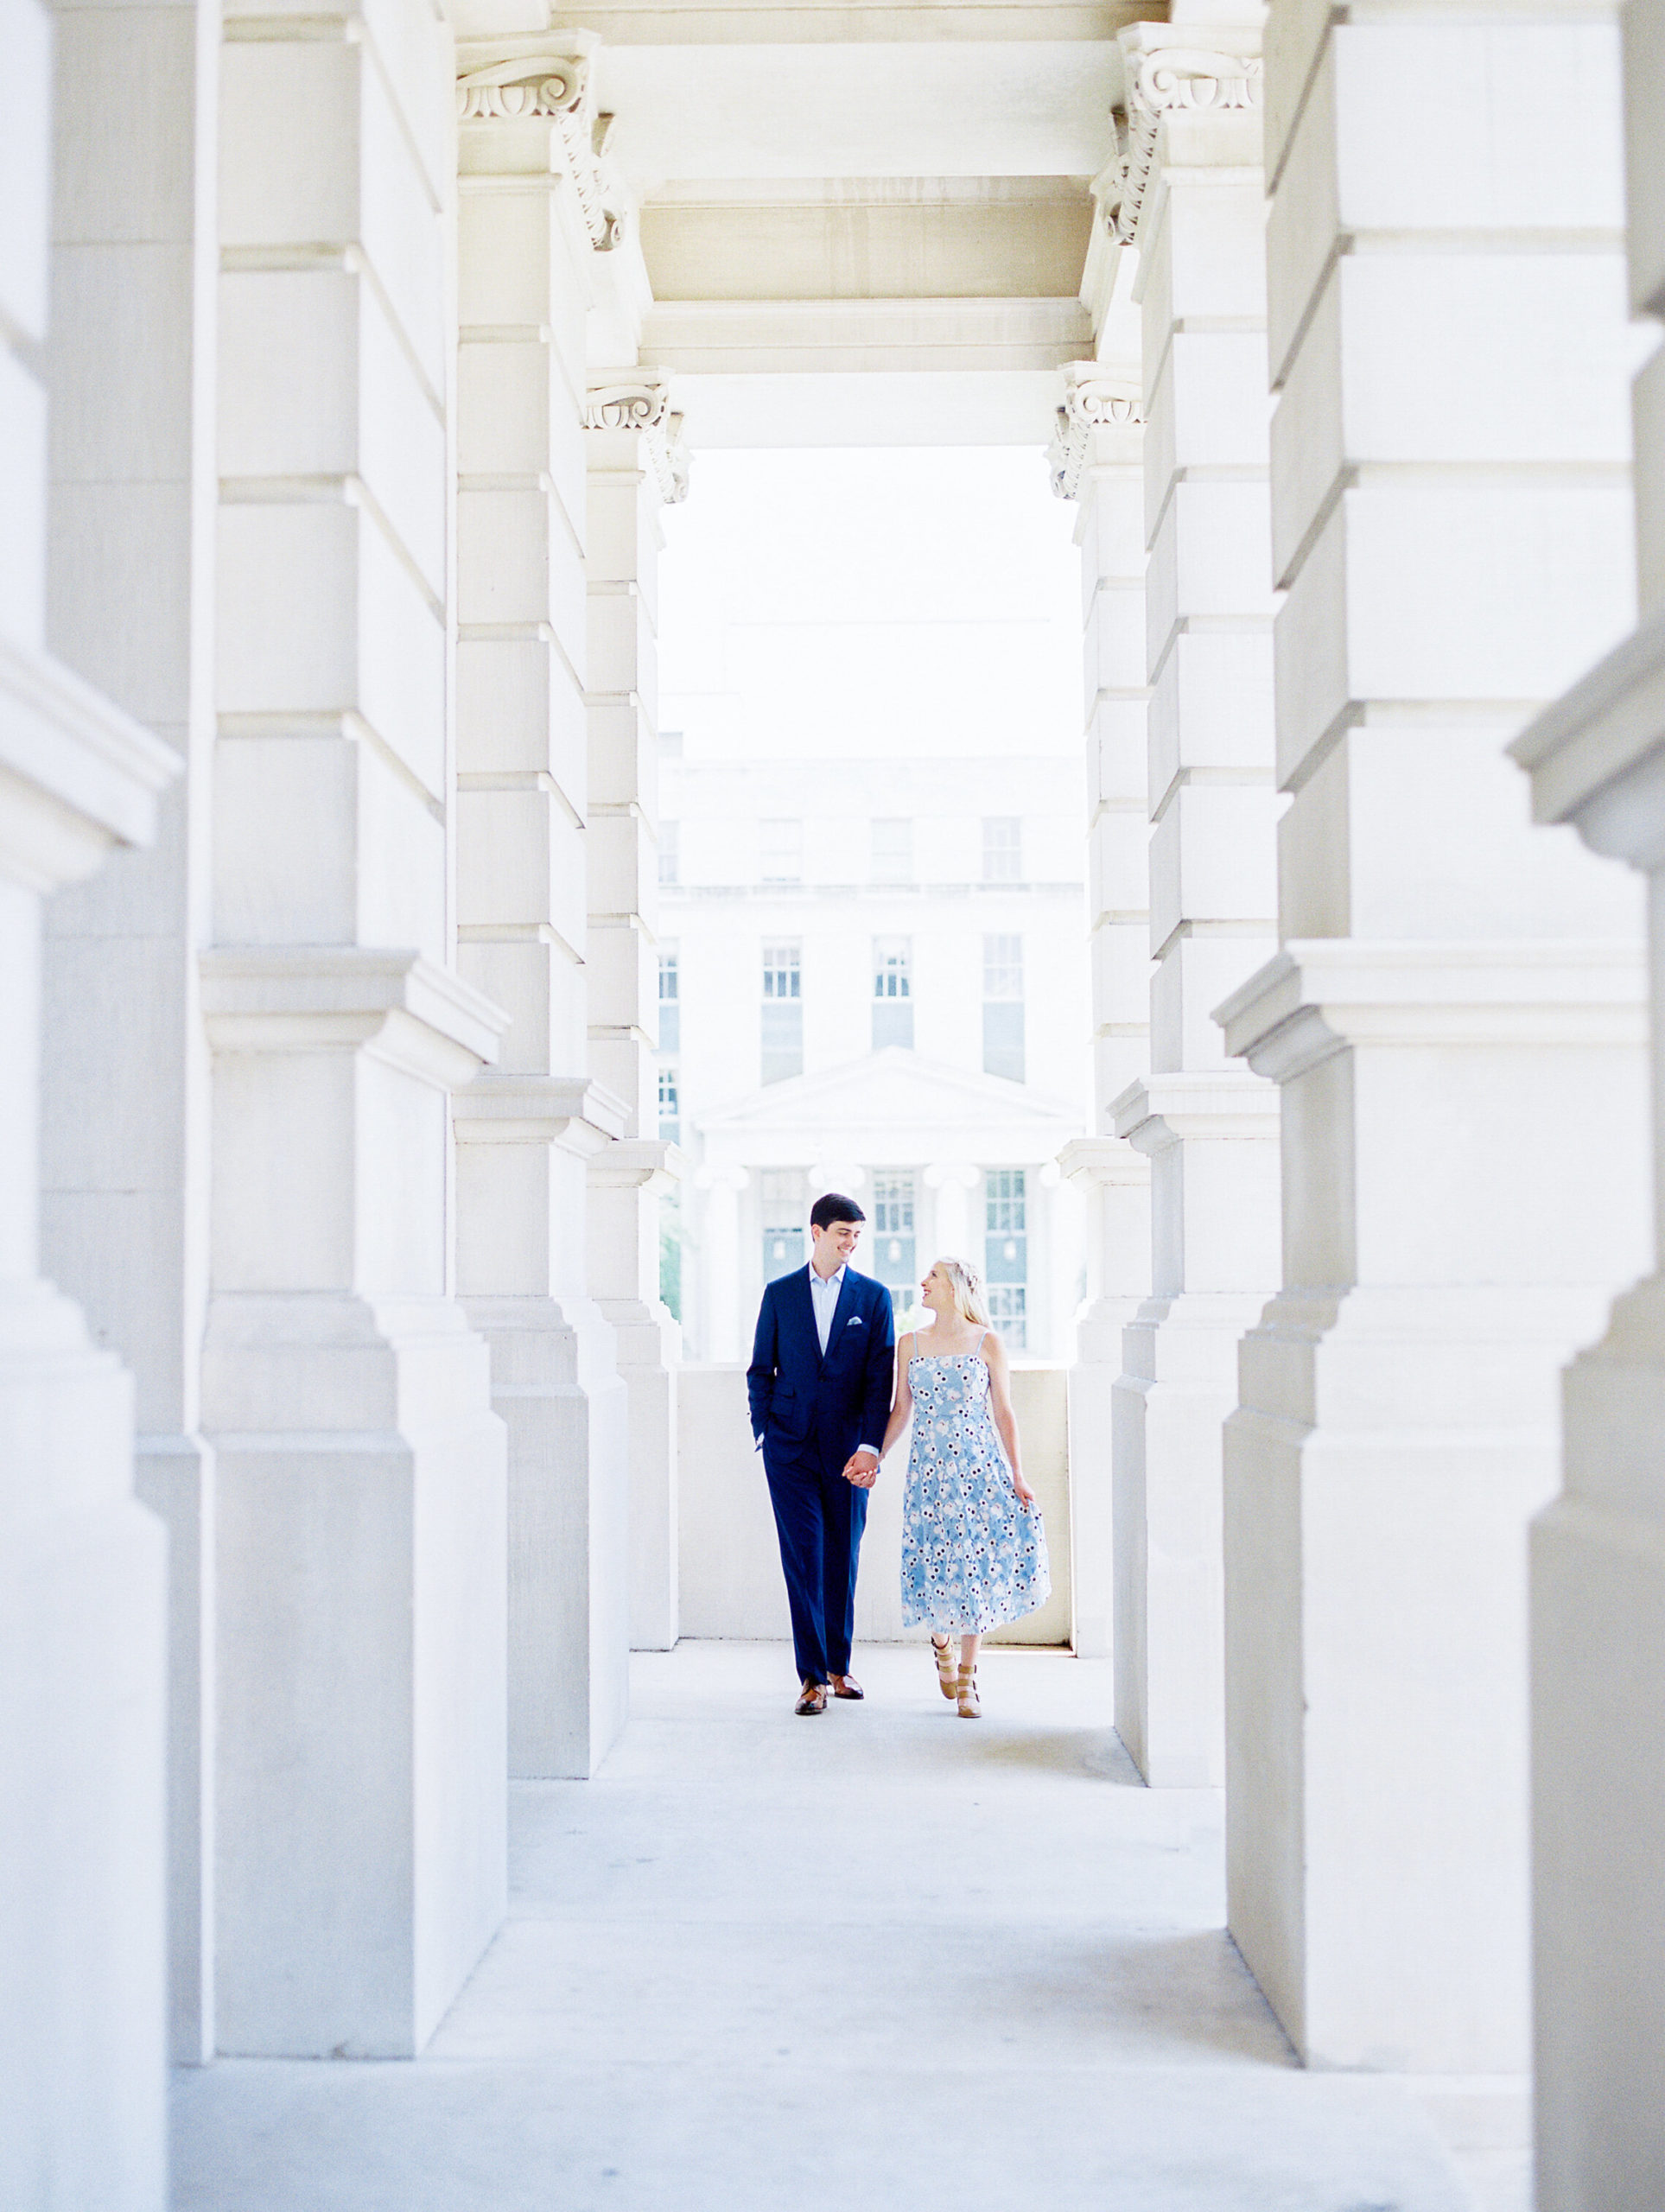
[875,1259,1052,1721]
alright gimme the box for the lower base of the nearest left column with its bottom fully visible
[203,1294,506,2057]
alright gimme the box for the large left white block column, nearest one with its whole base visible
[201,0,506,2057]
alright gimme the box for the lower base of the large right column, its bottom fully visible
[1225,1287,1603,2075]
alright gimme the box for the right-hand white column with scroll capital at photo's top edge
[1106,17,1278,1785]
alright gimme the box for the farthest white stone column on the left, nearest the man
[584,380,688,1650]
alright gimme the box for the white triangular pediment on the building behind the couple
[695,1044,1084,1157]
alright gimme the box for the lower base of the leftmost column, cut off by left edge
[0,1283,166,2212]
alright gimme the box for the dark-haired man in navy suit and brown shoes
[745,1190,895,1714]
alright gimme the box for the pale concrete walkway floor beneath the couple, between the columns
[175,1643,1530,2212]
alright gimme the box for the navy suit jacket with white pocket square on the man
[745,1265,895,1476]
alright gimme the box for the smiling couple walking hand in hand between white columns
[745,1192,1052,1721]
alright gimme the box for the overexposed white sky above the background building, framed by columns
[659,447,1081,759]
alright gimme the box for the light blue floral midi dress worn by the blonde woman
[902,1351,1052,1635]
